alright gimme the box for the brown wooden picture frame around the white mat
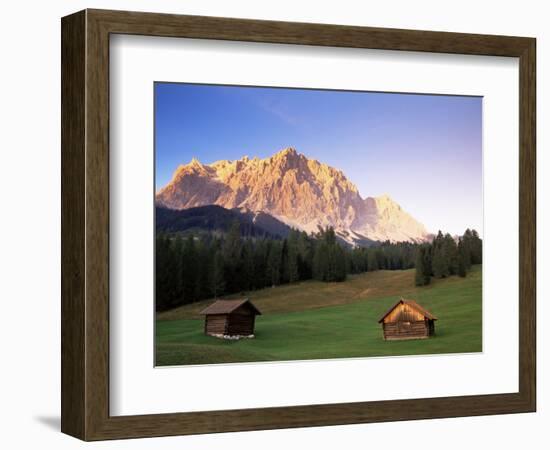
[61,10,536,440]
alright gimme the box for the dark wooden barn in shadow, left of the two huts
[200,298,262,337]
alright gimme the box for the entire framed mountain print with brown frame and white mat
[62,10,536,440]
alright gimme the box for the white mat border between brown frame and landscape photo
[110,35,519,415]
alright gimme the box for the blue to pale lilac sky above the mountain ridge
[155,83,482,234]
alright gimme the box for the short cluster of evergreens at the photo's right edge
[415,229,482,286]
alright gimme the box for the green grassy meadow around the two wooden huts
[156,266,482,366]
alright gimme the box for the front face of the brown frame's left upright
[85,12,109,439]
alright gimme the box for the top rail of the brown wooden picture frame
[88,10,529,57]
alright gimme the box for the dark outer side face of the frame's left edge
[61,12,86,437]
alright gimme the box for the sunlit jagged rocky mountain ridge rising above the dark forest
[156,148,428,243]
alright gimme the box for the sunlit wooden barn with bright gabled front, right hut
[378,298,437,340]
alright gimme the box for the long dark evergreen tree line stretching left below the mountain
[155,222,418,311]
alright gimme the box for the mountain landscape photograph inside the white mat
[153,81,483,366]
